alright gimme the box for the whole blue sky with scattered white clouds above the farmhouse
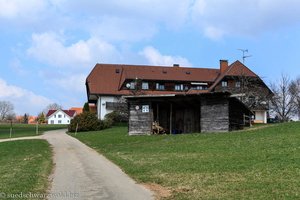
[0,0,300,115]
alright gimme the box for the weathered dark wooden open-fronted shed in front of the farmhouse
[126,92,253,135]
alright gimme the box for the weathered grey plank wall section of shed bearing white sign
[128,101,153,135]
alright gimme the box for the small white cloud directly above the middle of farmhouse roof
[140,46,192,67]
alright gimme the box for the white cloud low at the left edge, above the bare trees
[0,79,52,115]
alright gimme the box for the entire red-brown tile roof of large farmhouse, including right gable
[86,61,257,96]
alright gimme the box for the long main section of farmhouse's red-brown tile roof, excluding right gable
[86,64,219,95]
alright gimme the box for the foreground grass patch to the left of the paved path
[0,140,53,199]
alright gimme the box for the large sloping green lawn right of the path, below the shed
[72,123,300,199]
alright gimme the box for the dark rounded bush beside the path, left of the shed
[68,112,112,132]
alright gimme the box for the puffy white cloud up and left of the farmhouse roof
[27,33,119,69]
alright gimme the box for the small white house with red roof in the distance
[46,109,76,124]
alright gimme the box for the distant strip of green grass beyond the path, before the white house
[0,124,67,139]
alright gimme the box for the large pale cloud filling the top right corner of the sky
[191,0,300,39]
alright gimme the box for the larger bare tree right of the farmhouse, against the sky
[271,74,296,122]
